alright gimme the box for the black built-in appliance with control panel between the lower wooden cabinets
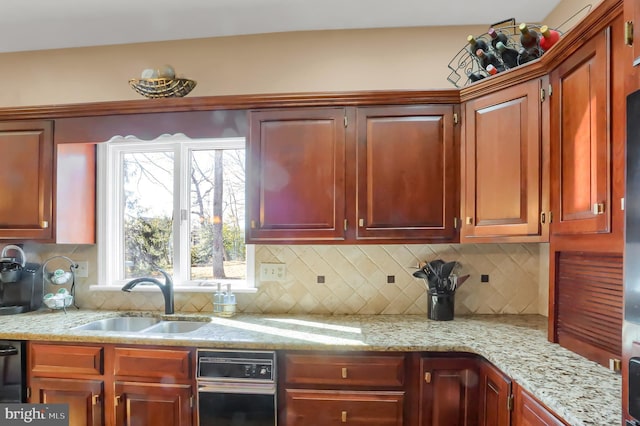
[196,349,277,426]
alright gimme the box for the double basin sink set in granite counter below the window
[73,316,207,334]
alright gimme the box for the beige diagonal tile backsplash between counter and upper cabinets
[24,244,548,315]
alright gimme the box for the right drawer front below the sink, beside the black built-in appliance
[113,348,192,379]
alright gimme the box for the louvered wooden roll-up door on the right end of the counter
[556,252,623,363]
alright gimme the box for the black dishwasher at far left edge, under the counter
[0,340,26,403]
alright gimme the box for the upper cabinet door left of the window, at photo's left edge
[0,121,53,240]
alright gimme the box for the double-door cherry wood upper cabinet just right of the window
[247,105,459,243]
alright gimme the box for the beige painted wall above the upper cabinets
[0,0,597,107]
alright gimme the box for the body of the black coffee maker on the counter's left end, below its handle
[0,262,43,315]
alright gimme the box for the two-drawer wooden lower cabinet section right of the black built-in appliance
[278,352,407,426]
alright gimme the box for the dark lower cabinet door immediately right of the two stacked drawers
[419,358,479,426]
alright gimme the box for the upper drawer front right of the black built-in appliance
[285,354,404,387]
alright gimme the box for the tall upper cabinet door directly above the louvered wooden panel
[550,29,612,235]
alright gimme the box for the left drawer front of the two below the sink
[29,343,104,376]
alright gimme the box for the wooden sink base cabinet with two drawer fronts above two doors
[27,342,196,426]
